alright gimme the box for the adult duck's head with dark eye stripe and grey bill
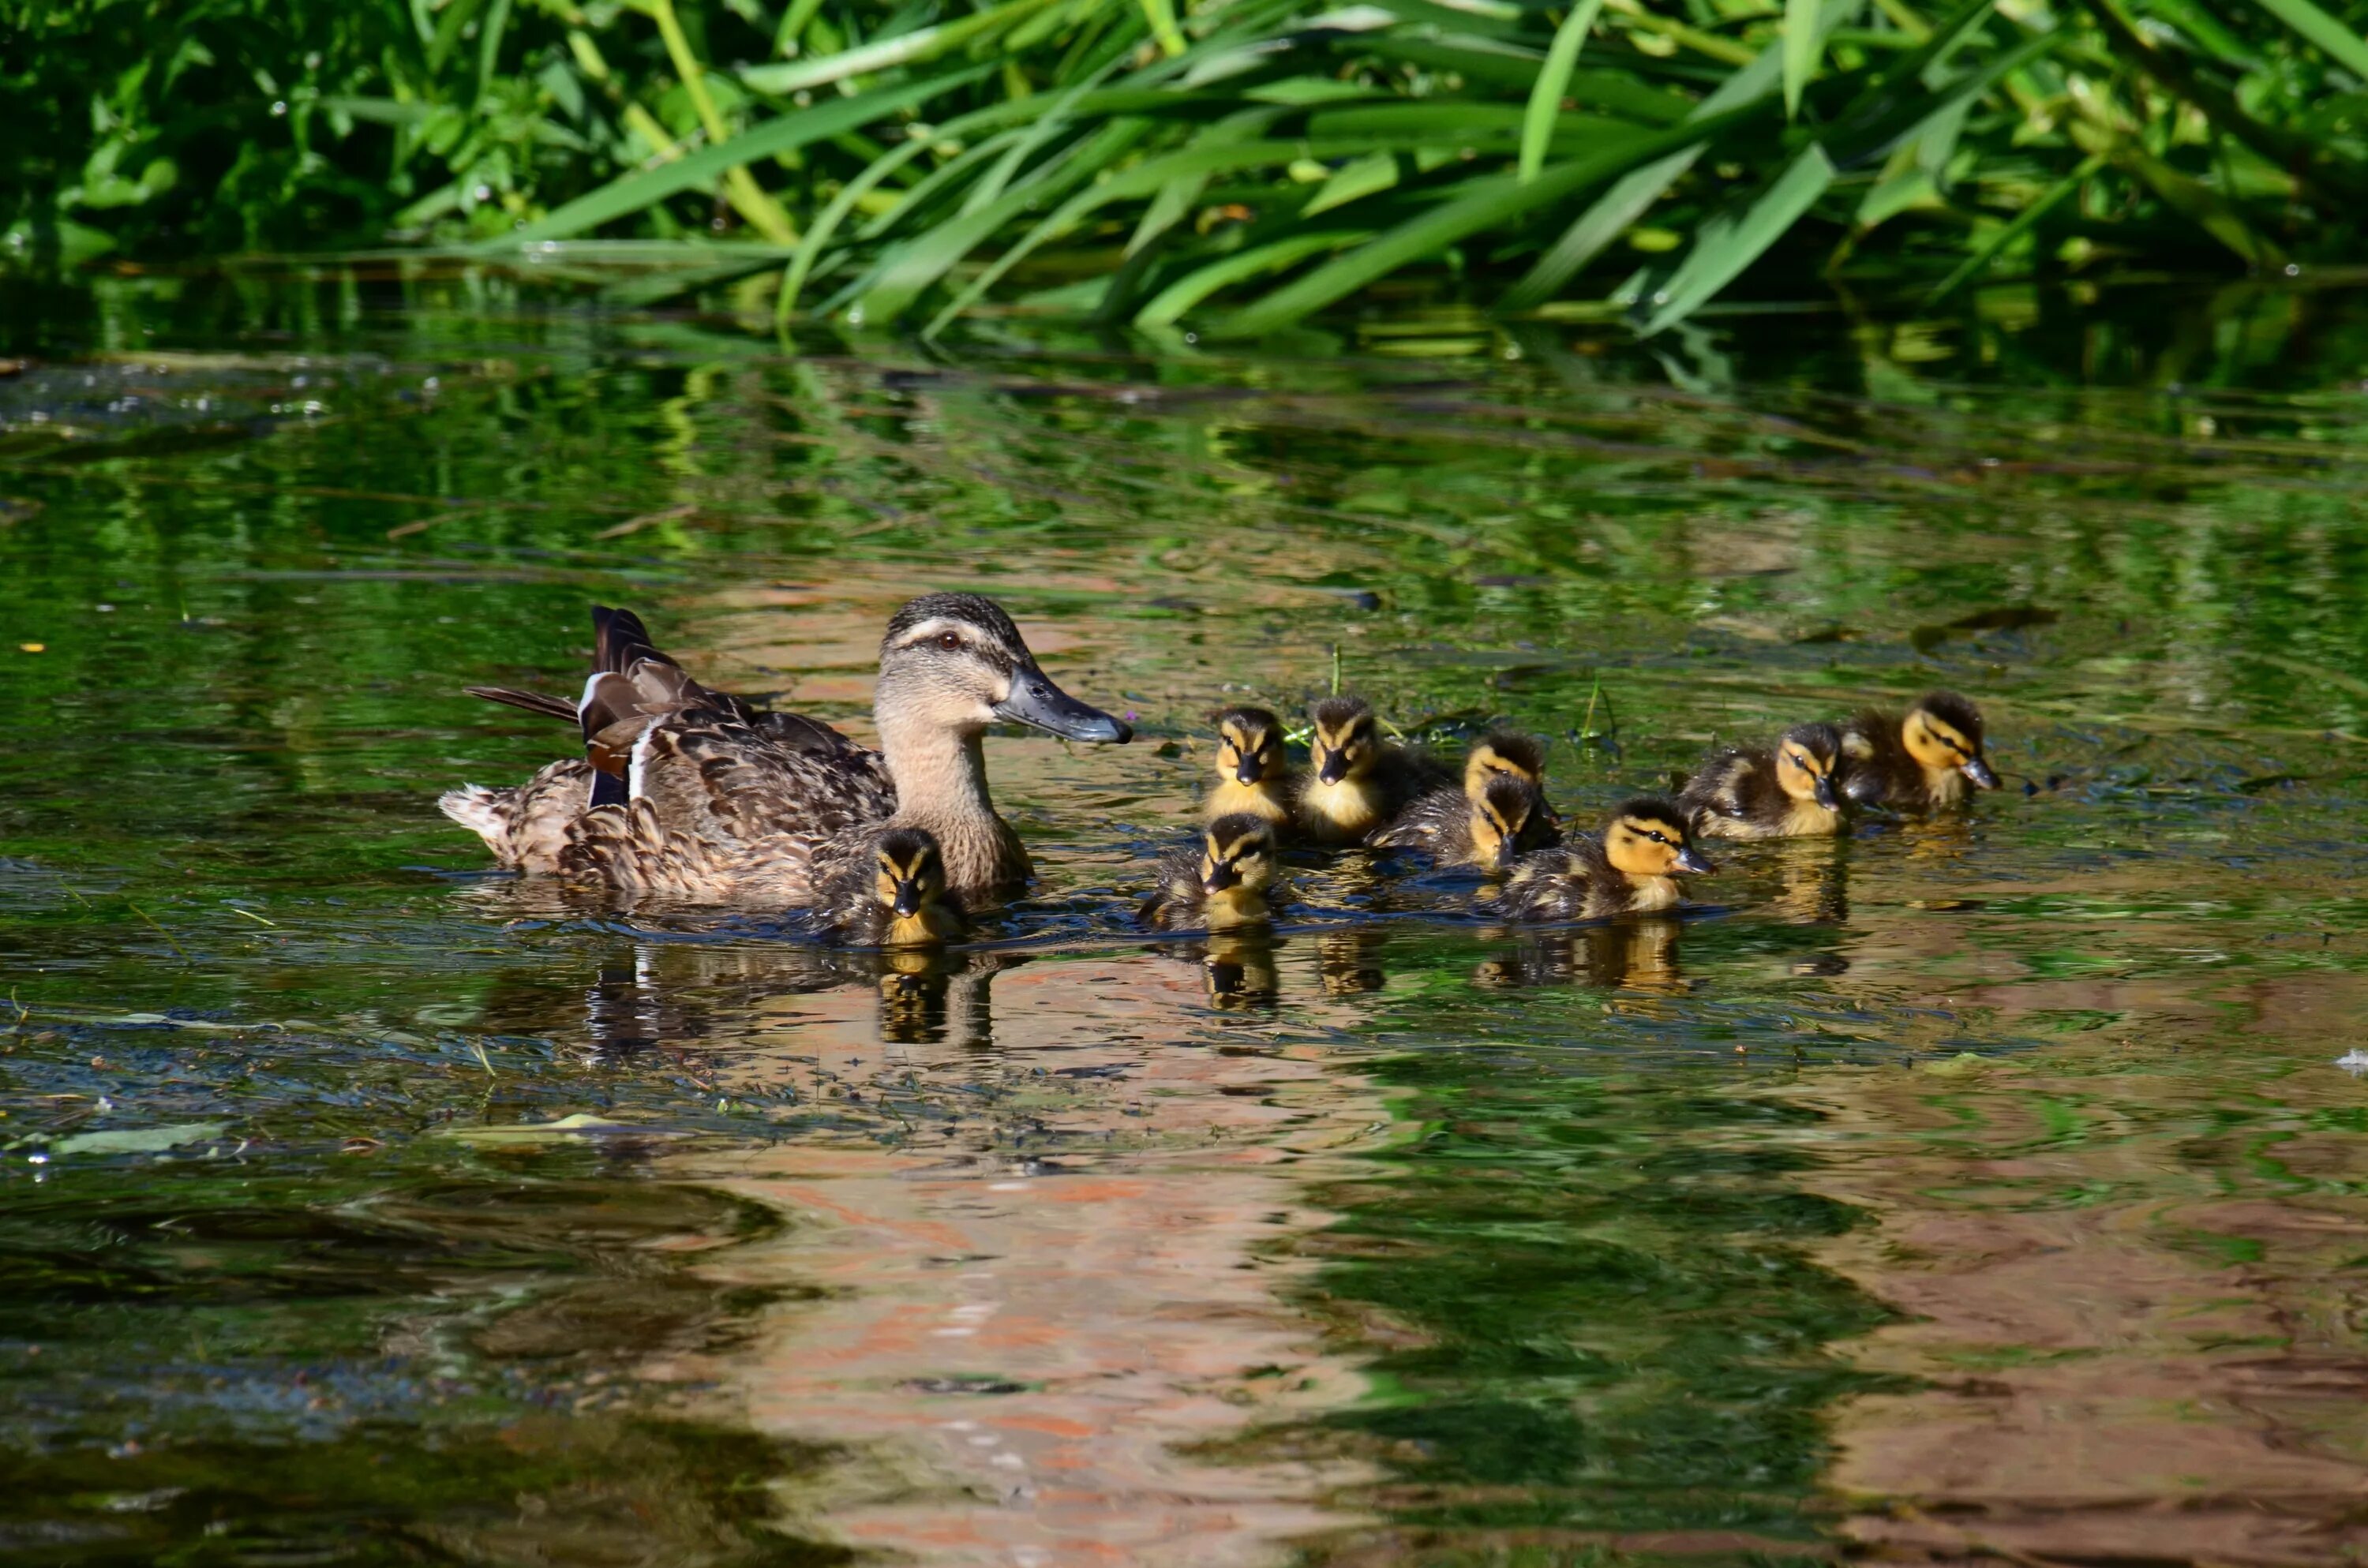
[874,594,1134,743]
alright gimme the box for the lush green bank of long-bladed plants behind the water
[0,0,2368,336]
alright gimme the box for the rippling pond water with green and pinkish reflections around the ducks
[0,268,2368,1568]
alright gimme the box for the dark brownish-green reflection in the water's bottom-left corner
[0,1156,836,1563]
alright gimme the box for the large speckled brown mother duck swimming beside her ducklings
[440,594,1134,907]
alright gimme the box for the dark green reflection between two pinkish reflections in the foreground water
[1243,955,1885,1537]
